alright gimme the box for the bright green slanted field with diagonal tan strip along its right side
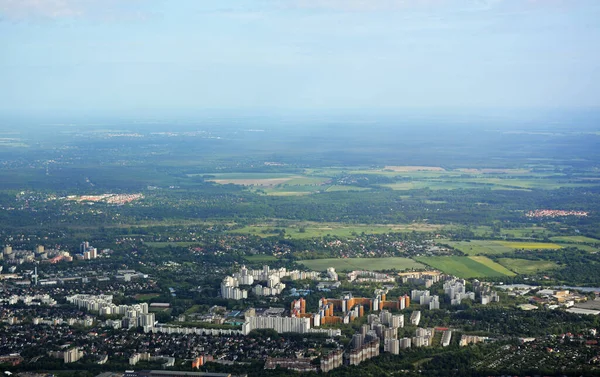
[415,257,515,279]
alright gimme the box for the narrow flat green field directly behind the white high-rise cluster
[298,257,425,271]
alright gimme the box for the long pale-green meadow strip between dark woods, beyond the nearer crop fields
[229,222,442,239]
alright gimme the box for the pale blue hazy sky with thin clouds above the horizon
[0,0,600,115]
